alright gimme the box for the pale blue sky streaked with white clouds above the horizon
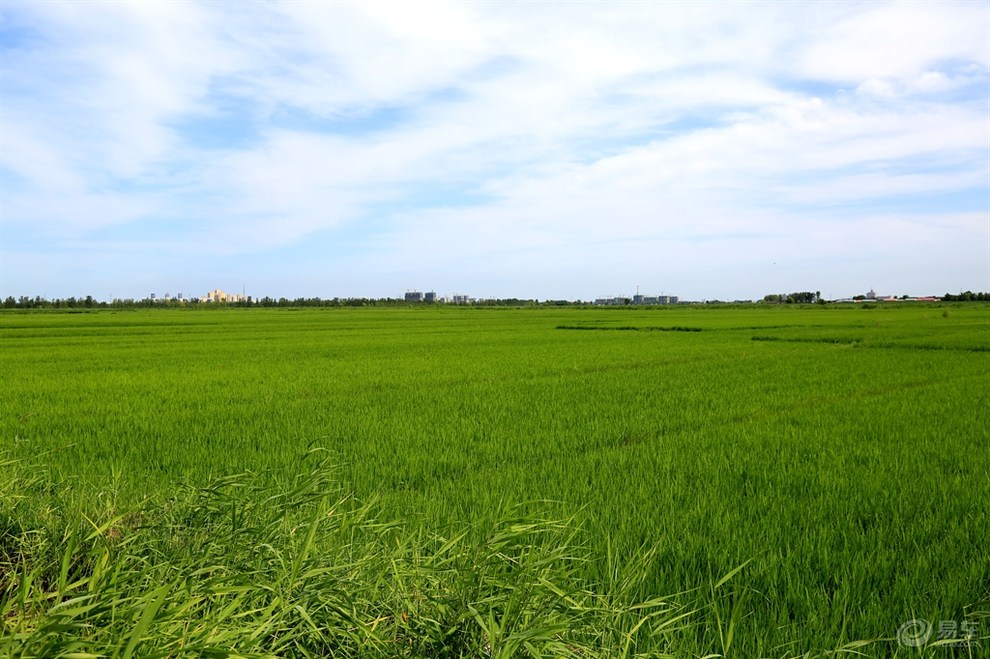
[0,0,990,300]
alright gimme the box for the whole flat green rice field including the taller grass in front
[0,303,990,657]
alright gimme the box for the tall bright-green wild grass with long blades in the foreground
[0,459,692,658]
